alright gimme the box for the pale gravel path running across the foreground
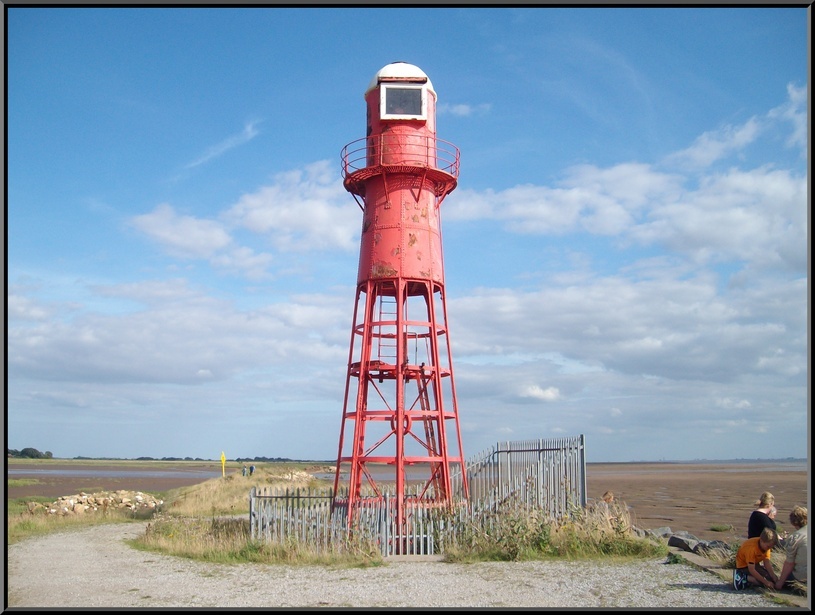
[6,523,792,609]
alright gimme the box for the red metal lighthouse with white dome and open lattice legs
[334,62,468,524]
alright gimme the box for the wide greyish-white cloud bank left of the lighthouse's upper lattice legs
[9,279,348,384]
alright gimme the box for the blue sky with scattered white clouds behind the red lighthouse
[5,7,809,462]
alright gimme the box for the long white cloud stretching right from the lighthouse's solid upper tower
[445,149,808,271]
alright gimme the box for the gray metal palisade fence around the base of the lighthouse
[249,435,587,557]
